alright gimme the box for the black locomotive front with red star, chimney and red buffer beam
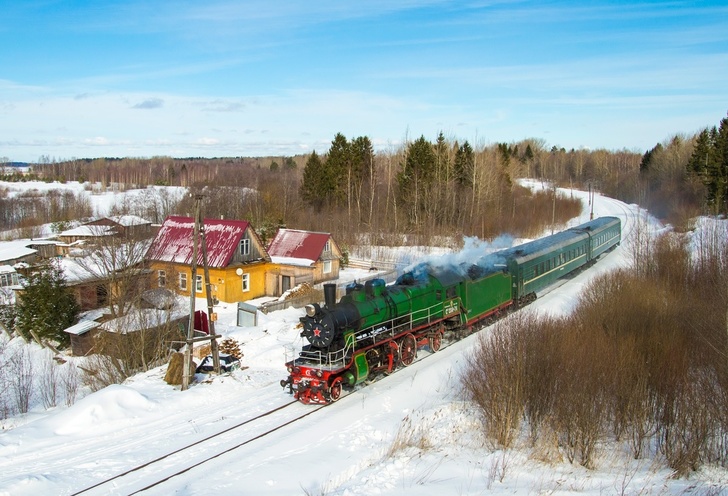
[281,284,357,404]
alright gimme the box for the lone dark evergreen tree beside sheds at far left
[15,261,79,346]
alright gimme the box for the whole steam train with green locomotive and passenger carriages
[281,217,621,404]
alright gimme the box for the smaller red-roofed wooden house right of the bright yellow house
[267,229,341,296]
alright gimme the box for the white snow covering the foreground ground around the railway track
[0,182,728,496]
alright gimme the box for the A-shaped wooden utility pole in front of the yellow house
[182,195,220,391]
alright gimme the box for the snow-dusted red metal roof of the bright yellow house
[147,216,250,267]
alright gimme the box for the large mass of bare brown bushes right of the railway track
[462,227,728,476]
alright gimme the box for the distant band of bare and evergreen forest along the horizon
[0,111,728,245]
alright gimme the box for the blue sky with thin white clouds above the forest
[0,0,728,161]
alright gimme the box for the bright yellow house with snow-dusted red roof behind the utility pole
[146,216,270,303]
